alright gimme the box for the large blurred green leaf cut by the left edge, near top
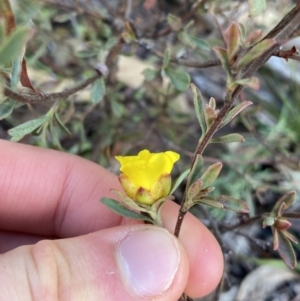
[0,27,28,66]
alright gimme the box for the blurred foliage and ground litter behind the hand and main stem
[0,0,300,300]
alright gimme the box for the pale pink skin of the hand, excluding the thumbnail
[0,140,223,301]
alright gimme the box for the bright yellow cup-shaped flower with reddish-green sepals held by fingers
[116,150,180,205]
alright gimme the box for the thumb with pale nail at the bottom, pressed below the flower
[0,225,188,301]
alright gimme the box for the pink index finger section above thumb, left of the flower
[0,140,123,237]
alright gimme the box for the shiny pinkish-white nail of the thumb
[117,226,180,297]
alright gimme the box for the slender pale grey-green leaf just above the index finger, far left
[8,114,50,141]
